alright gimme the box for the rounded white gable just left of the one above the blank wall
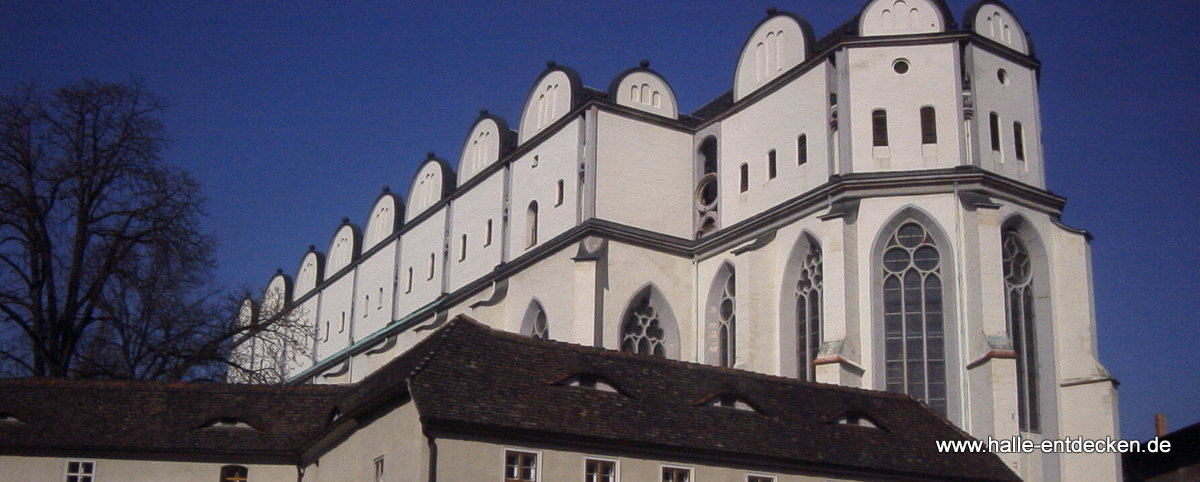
[520,60,583,143]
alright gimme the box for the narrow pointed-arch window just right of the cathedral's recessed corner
[704,261,737,367]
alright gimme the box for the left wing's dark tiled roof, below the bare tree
[0,379,341,462]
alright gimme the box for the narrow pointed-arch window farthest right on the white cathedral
[998,215,1057,436]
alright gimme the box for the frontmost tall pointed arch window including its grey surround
[870,205,962,421]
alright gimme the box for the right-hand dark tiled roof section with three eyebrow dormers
[410,319,1015,480]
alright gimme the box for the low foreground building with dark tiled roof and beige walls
[0,319,1016,482]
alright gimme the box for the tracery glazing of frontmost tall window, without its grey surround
[882,219,948,416]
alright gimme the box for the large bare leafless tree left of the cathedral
[0,80,271,380]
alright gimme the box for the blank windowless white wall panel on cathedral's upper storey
[592,110,692,237]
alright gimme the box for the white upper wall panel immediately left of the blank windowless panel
[505,118,583,259]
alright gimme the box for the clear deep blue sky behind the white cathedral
[0,0,1200,439]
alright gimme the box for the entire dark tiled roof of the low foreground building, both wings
[0,318,1015,480]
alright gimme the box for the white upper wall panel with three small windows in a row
[718,62,829,227]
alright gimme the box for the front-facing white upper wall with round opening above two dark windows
[839,43,961,173]
